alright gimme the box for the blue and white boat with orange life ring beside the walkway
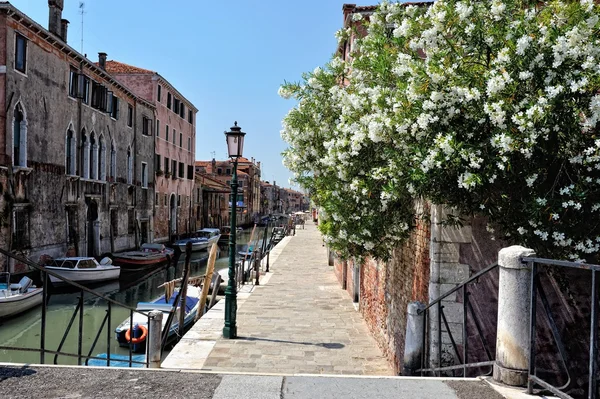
[115,285,202,352]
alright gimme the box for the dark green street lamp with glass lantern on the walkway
[223,122,246,339]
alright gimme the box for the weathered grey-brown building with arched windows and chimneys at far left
[0,0,155,271]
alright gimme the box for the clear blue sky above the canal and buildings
[14,0,350,189]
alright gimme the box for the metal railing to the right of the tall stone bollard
[522,257,600,399]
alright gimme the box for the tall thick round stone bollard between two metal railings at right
[494,245,535,386]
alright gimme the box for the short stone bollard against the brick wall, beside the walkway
[402,301,425,376]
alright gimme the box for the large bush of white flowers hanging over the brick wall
[280,0,600,260]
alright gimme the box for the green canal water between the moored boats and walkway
[0,227,264,365]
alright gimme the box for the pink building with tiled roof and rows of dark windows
[106,61,198,242]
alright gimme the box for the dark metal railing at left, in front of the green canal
[0,248,150,367]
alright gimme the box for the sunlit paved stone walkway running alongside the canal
[162,223,393,375]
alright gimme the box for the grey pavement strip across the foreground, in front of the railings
[0,364,534,399]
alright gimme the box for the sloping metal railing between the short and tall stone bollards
[416,264,498,377]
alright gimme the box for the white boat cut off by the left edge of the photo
[0,272,44,319]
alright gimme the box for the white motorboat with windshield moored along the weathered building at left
[45,257,121,284]
